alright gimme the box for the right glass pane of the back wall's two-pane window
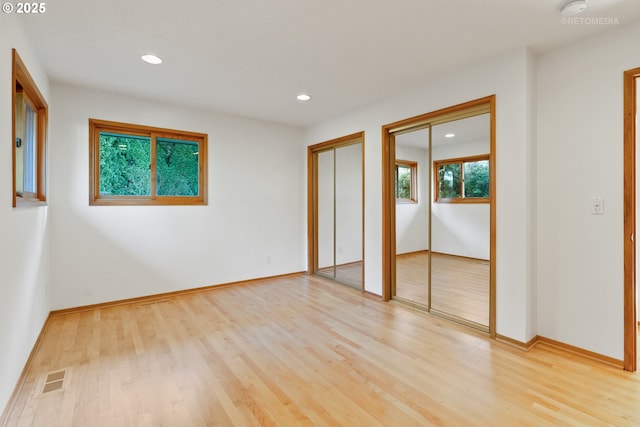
[156,138,200,196]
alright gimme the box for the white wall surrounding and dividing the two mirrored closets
[305,48,535,341]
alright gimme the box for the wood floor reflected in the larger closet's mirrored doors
[396,251,489,326]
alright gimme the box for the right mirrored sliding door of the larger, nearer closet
[431,113,491,327]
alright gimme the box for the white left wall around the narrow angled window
[0,13,51,414]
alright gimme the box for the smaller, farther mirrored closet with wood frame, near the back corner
[307,132,364,292]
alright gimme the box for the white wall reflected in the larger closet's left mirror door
[396,142,431,254]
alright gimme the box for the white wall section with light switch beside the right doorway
[537,24,640,360]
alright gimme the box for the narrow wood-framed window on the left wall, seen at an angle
[11,49,48,207]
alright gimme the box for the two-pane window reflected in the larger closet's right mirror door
[433,154,490,203]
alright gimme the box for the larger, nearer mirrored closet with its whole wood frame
[382,96,496,336]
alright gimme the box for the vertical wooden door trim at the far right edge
[623,68,640,372]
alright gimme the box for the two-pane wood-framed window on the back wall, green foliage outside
[89,119,207,205]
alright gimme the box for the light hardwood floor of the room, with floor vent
[5,275,640,427]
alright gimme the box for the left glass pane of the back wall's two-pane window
[100,132,151,196]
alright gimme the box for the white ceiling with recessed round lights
[13,0,640,126]
